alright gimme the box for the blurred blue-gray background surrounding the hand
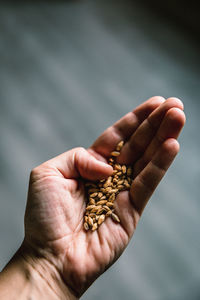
[0,0,200,300]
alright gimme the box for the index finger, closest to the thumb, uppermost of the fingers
[90,96,165,157]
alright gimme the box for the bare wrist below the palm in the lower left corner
[0,247,78,300]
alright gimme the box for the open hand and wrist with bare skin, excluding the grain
[0,96,185,300]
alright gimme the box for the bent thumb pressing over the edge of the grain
[47,147,113,180]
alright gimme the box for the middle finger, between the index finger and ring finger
[118,98,183,164]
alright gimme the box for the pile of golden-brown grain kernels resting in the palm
[84,141,132,231]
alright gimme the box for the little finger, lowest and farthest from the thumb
[130,139,179,215]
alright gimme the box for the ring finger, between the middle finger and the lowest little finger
[134,108,185,176]
